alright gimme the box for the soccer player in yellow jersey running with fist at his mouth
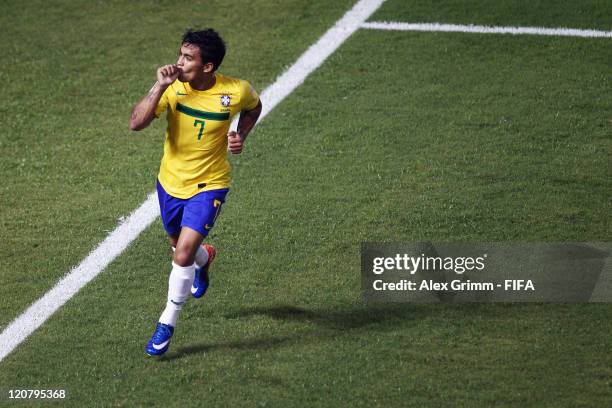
[130,29,261,355]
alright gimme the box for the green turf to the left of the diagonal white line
[0,1,350,327]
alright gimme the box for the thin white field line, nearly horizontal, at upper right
[361,21,612,38]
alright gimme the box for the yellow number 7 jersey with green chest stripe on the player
[155,74,259,199]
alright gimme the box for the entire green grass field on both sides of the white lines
[0,0,612,407]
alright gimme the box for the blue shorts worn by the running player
[157,180,229,237]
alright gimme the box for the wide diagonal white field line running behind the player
[0,0,384,361]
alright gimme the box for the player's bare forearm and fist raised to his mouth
[130,65,179,130]
